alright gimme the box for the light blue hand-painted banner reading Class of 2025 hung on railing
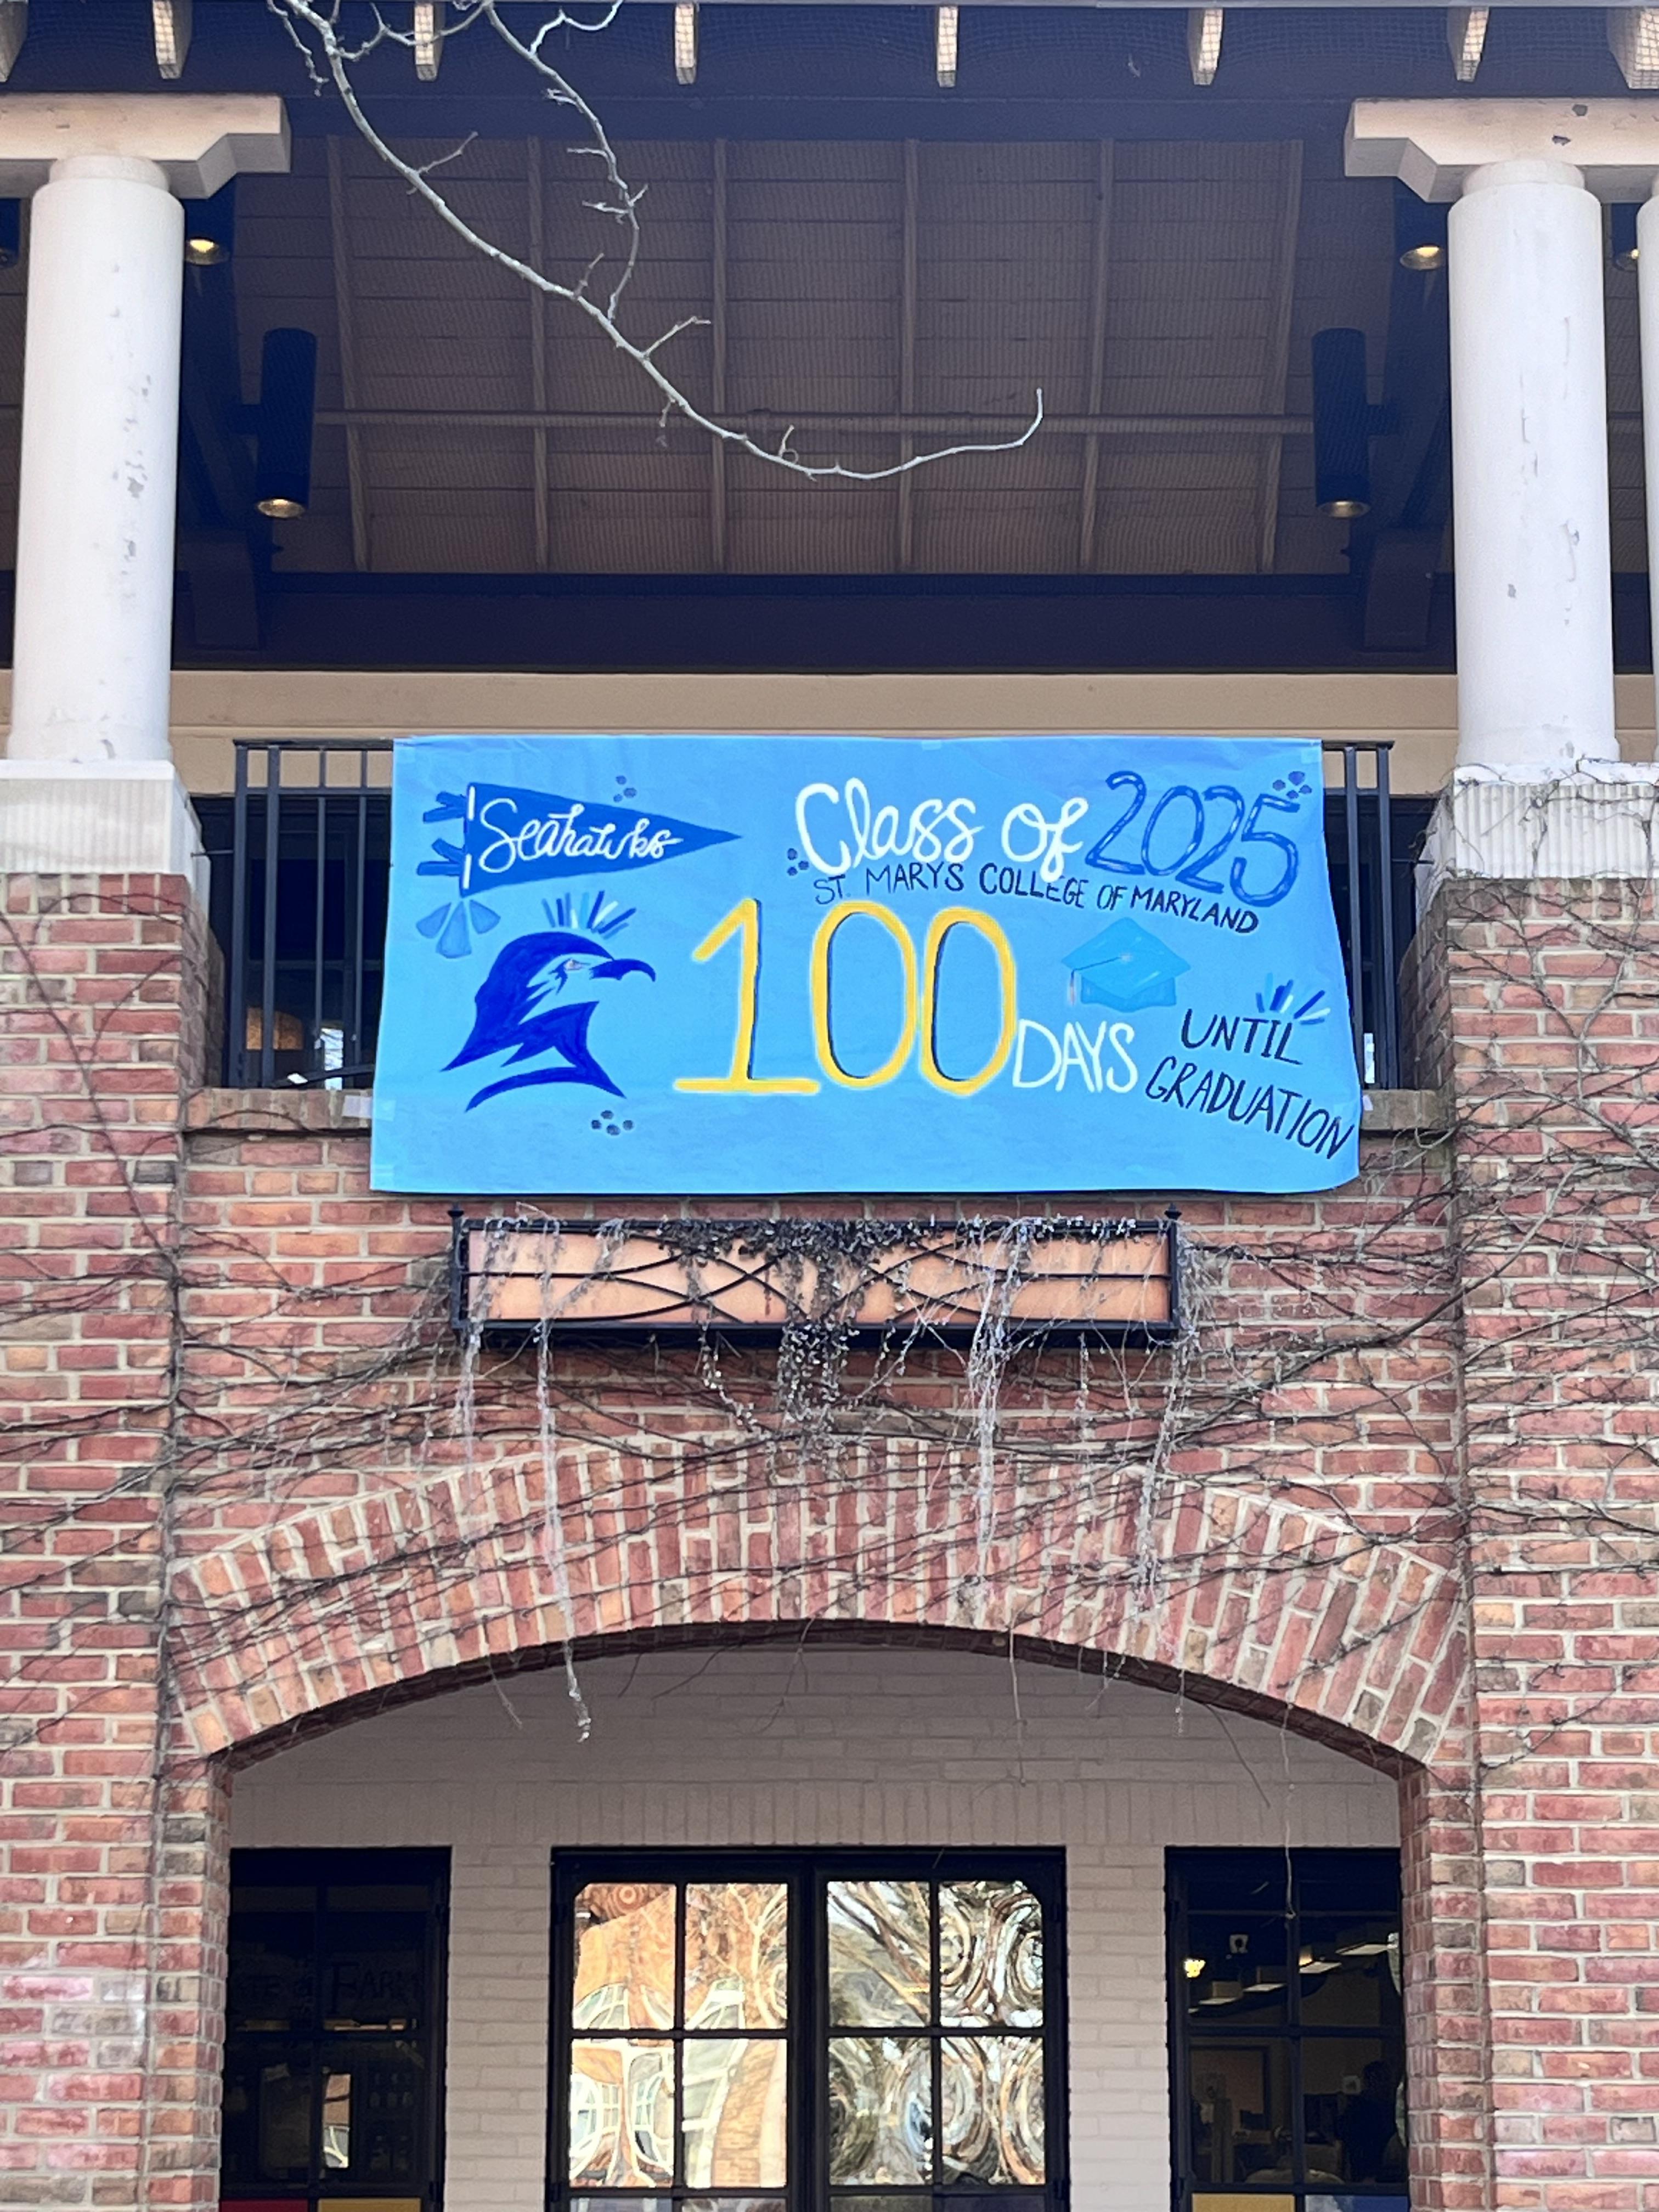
[374,737,1361,1197]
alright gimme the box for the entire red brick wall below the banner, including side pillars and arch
[0,858,1659,2212]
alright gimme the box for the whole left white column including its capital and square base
[0,93,287,889]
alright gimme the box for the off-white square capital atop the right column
[1342,97,1659,199]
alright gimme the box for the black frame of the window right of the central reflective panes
[1166,1849,1409,2212]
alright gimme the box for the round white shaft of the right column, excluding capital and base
[1449,157,1619,783]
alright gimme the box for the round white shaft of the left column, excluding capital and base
[11,153,184,763]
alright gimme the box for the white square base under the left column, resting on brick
[0,761,208,905]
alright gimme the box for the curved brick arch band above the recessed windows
[170,1460,1464,1772]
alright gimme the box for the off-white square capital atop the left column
[0,93,290,199]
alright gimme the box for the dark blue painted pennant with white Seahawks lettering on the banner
[418,783,735,898]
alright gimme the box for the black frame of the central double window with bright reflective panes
[544,1845,1070,2212]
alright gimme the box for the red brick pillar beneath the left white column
[0,876,225,2212]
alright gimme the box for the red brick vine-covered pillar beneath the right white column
[1420,878,1659,2212]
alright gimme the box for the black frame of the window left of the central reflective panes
[219,1845,452,2212]
